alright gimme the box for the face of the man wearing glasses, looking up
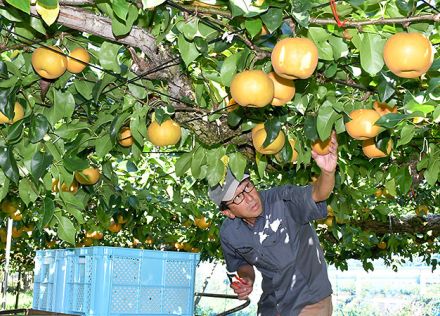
[223,179,263,224]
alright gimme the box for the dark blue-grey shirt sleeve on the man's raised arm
[280,185,327,224]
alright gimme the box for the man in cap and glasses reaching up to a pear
[209,132,338,316]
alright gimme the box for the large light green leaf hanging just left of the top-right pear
[359,33,385,76]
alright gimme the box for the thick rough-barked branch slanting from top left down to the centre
[0,0,248,145]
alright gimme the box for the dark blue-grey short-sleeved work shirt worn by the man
[220,185,332,316]
